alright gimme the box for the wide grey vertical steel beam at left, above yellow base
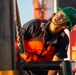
[0,0,16,70]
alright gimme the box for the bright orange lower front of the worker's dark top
[24,40,55,62]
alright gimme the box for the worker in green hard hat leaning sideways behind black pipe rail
[15,7,76,75]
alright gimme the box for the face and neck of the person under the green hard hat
[50,11,69,34]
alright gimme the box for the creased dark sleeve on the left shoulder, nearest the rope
[22,19,41,40]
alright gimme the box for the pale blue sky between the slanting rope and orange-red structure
[17,0,34,25]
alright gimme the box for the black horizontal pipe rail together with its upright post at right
[22,60,72,75]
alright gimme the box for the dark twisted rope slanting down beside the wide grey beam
[16,1,25,53]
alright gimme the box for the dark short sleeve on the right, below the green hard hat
[55,35,69,58]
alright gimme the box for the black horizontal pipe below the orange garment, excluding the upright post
[22,61,62,70]
